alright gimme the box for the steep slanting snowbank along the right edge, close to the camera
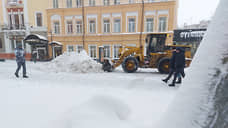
[157,0,228,128]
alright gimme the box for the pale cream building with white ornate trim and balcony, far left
[0,0,48,59]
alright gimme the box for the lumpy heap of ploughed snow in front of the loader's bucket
[47,51,103,73]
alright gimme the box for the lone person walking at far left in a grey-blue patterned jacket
[15,45,28,78]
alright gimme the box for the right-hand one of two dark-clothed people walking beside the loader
[169,48,185,86]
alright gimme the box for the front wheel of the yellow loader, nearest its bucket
[122,57,139,73]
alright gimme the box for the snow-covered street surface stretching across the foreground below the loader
[0,60,179,128]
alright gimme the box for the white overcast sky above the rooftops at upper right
[178,0,219,26]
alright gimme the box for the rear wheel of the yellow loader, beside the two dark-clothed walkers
[158,58,170,74]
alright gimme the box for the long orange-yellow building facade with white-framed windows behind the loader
[47,0,178,59]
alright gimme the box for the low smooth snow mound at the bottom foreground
[52,96,132,128]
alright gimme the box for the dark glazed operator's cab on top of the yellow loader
[146,34,167,56]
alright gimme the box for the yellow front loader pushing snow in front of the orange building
[103,33,191,73]
